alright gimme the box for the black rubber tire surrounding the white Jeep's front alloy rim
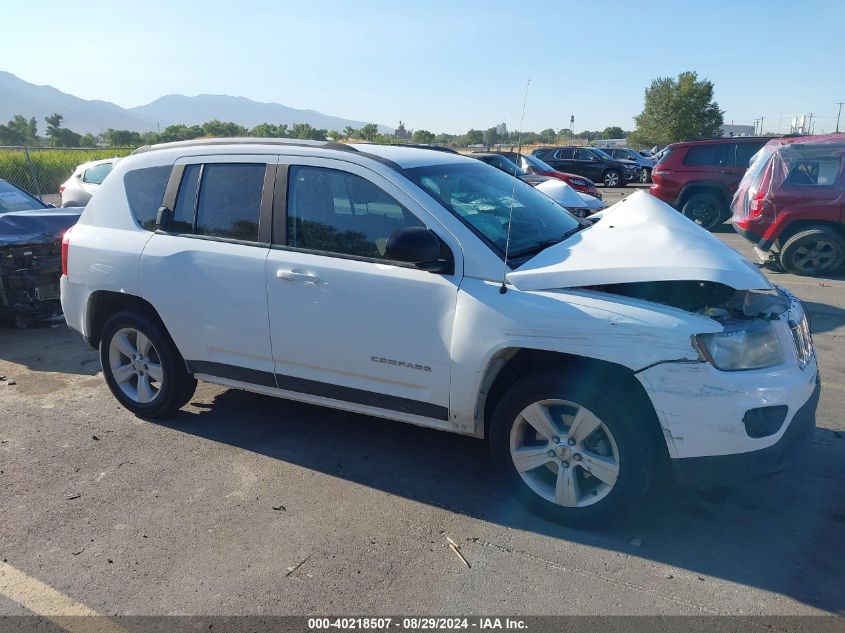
[488,369,659,527]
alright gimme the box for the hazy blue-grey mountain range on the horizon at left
[0,71,393,134]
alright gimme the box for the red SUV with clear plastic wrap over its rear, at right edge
[731,134,845,275]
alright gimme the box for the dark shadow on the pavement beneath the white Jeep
[156,390,845,613]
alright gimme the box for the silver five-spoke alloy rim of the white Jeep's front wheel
[510,400,619,508]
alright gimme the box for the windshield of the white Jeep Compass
[405,163,580,265]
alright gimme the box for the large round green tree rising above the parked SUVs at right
[631,71,724,146]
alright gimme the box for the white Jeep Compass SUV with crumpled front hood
[61,139,819,524]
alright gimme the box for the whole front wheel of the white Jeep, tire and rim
[489,370,657,527]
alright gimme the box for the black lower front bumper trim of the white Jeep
[672,376,821,485]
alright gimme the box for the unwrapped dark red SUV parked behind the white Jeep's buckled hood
[649,136,772,229]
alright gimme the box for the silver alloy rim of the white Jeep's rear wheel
[109,327,164,404]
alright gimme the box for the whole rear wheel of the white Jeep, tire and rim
[100,312,197,418]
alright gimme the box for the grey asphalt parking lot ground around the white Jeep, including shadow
[0,187,845,615]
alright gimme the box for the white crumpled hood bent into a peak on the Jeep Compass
[507,191,772,290]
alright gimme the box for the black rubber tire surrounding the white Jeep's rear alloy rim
[100,312,197,418]
